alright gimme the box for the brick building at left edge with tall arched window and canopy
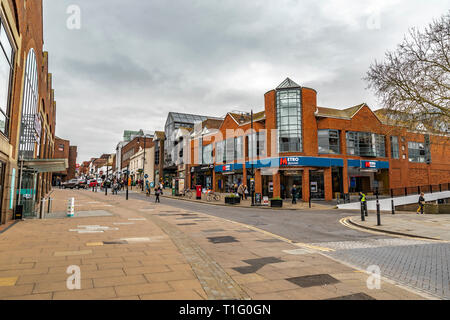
[0,0,58,224]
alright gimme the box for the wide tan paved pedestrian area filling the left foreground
[0,190,424,300]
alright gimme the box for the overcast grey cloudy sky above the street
[44,0,450,163]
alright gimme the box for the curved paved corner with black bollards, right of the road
[350,213,450,241]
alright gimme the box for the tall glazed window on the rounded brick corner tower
[277,89,303,152]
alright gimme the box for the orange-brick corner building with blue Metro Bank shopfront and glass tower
[187,78,450,201]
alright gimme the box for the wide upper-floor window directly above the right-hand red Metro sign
[347,132,386,157]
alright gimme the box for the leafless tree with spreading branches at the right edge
[365,11,450,134]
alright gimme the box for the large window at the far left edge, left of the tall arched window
[0,19,14,136]
